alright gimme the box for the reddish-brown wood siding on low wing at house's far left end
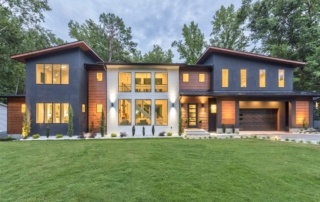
[7,97,25,134]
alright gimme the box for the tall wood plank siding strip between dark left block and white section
[88,70,107,132]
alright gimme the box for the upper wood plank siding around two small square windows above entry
[179,70,211,90]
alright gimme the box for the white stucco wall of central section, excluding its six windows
[107,65,179,137]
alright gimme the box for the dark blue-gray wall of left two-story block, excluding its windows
[26,48,95,135]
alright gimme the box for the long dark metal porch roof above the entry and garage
[180,90,320,97]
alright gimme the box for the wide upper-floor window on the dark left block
[36,64,69,84]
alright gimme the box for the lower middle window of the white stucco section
[135,100,151,125]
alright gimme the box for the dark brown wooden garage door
[239,109,278,131]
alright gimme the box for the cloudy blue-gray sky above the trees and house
[43,0,241,62]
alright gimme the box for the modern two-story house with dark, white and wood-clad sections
[5,41,319,135]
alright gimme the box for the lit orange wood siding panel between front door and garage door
[221,101,236,125]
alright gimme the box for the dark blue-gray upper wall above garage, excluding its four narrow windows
[204,54,293,91]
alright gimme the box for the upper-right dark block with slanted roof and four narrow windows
[198,48,305,91]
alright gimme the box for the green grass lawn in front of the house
[0,139,320,201]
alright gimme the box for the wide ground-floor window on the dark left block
[36,103,69,123]
